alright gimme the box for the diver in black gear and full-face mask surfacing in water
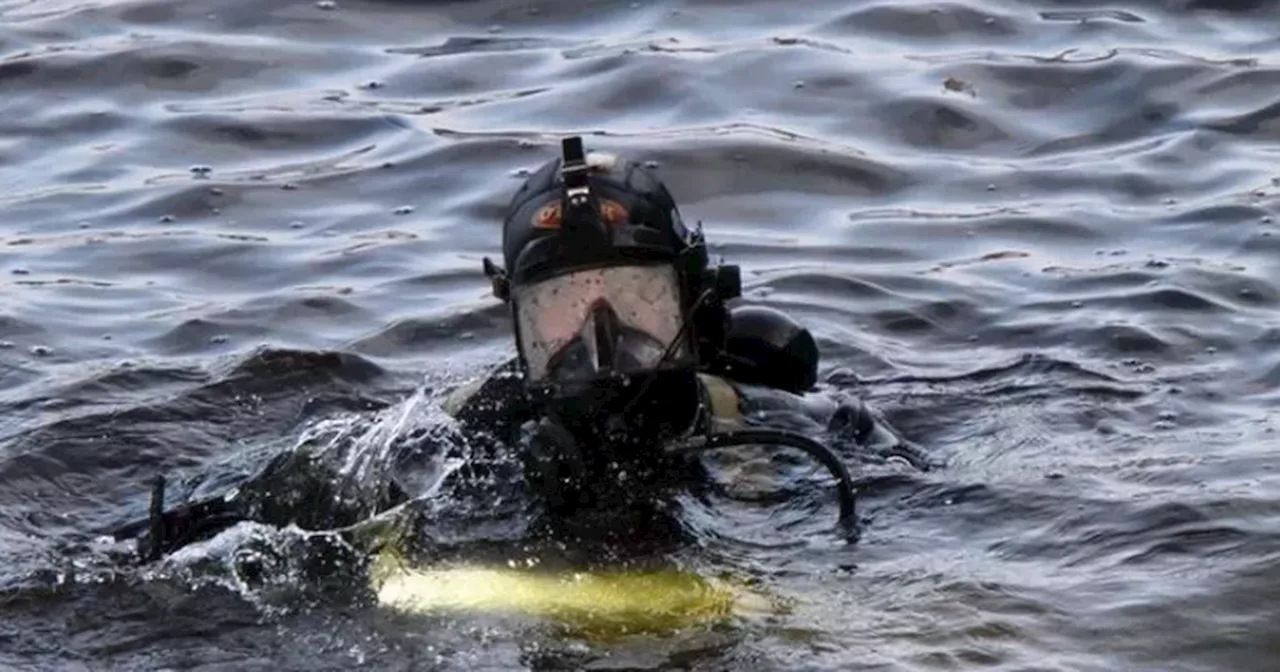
[115,137,929,559]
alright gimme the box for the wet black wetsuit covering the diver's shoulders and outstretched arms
[116,361,929,559]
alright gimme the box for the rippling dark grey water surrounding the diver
[0,0,1280,671]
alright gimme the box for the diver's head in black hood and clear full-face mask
[485,137,740,440]
